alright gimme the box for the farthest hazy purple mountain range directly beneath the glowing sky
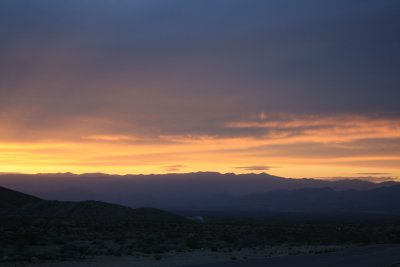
[0,172,396,209]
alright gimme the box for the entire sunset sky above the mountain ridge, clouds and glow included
[0,0,400,179]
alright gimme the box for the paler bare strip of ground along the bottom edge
[4,245,400,267]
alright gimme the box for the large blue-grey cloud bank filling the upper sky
[0,0,400,139]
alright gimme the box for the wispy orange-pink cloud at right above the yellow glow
[225,114,400,142]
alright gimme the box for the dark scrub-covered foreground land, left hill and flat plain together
[0,188,400,262]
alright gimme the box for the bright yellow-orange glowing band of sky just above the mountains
[0,113,400,178]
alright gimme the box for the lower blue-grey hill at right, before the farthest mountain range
[230,185,400,213]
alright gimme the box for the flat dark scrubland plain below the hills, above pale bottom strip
[0,218,400,261]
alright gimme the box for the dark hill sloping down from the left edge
[0,187,185,224]
